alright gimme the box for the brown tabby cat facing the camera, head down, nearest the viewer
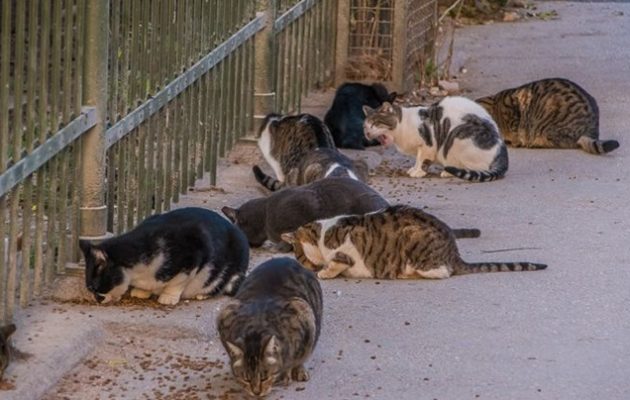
[217,257,323,396]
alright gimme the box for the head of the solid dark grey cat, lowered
[221,198,267,247]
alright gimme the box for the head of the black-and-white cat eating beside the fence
[79,240,129,303]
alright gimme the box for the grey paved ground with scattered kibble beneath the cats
[0,2,630,400]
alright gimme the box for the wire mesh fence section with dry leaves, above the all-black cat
[337,0,437,91]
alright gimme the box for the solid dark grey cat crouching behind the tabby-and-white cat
[221,177,389,252]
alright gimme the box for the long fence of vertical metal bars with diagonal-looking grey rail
[0,0,337,322]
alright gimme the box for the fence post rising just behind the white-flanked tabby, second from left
[250,0,276,137]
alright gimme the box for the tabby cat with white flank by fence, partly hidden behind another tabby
[258,114,335,186]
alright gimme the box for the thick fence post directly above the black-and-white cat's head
[79,0,109,239]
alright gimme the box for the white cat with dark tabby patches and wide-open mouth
[363,96,508,182]
